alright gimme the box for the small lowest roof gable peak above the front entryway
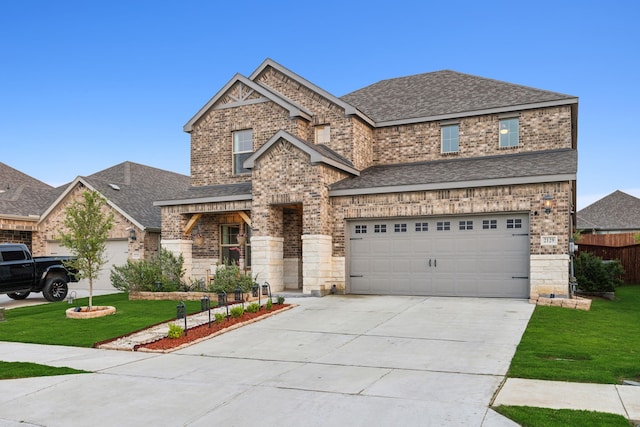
[243,130,360,176]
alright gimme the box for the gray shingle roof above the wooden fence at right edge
[577,190,640,230]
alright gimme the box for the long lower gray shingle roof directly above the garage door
[330,149,578,191]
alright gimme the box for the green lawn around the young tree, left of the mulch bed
[0,293,200,347]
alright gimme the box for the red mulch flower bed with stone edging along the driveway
[138,304,293,352]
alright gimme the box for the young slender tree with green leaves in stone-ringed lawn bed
[60,191,113,311]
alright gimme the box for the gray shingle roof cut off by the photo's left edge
[0,162,53,216]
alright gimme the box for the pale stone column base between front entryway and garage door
[302,234,333,295]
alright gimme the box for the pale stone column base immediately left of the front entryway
[251,236,284,292]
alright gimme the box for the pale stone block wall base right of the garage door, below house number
[530,254,569,298]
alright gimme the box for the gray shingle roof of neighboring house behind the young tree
[83,162,191,229]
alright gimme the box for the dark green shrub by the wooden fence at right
[573,252,624,292]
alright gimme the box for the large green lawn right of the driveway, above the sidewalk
[508,285,640,384]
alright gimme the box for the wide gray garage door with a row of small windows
[348,214,529,298]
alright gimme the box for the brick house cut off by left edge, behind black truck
[0,162,54,249]
